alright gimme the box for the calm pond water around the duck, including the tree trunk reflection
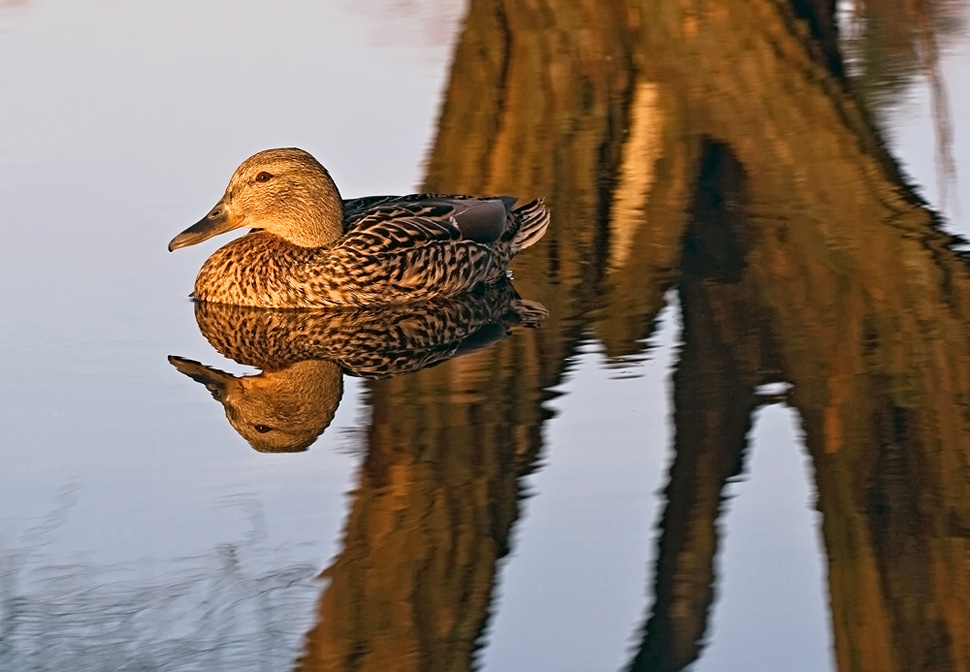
[0,0,970,671]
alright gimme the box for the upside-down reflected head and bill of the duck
[168,356,343,453]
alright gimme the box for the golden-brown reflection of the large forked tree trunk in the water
[292,0,970,671]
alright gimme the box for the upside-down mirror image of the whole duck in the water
[169,281,547,453]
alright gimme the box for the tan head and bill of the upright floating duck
[168,148,344,251]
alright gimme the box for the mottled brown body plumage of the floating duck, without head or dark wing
[195,196,548,307]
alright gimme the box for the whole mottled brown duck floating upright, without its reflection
[168,147,550,308]
